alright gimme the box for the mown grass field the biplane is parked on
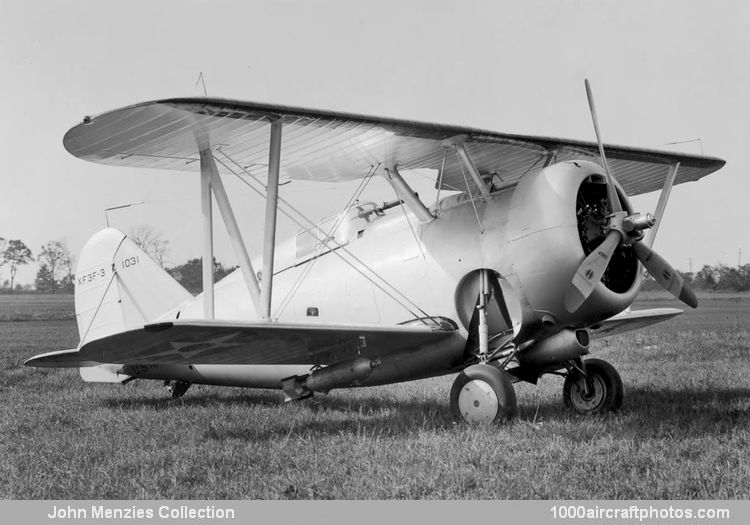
[0,294,750,499]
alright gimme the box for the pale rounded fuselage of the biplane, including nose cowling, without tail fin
[126,162,640,388]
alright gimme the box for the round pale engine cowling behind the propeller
[507,161,642,332]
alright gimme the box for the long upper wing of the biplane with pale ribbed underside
[63,98,725,195]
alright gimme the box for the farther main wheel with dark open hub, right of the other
[563,359,623,414]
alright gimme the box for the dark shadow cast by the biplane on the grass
[105,382,750,441]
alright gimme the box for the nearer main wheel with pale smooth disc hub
[451,365,516,425]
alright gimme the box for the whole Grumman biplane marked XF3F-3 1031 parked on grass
[26,82,724,423]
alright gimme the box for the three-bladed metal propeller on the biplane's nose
[564,79,698,312]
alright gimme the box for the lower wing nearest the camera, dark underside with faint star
[25,321,456,367]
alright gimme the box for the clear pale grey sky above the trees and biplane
[0,0,750,283]
